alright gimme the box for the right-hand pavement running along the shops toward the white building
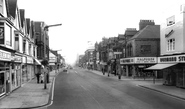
[88,70,185,100]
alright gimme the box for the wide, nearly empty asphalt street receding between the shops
[47,68,185,109]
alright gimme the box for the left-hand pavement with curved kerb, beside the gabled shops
[0,69,62,109]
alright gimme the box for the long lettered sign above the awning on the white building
[158,55,185,63]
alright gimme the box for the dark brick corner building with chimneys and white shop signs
[120,20,160,77]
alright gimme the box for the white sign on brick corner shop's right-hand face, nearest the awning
[135,57,157,64]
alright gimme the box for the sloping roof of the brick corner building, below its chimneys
[129,25,160,40]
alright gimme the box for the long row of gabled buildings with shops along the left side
[0,0,37,96]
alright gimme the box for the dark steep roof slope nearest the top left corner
[7,0,17,19]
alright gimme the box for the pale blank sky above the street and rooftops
[18,0,185,64]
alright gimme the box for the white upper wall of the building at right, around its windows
[160,4,185,55]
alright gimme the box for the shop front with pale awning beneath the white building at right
[147,55,185,88]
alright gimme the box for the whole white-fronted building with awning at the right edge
[147,4,185,88]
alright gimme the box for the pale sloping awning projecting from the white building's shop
[145,63,177,70]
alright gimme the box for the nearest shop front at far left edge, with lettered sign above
[0,50,11,96]
